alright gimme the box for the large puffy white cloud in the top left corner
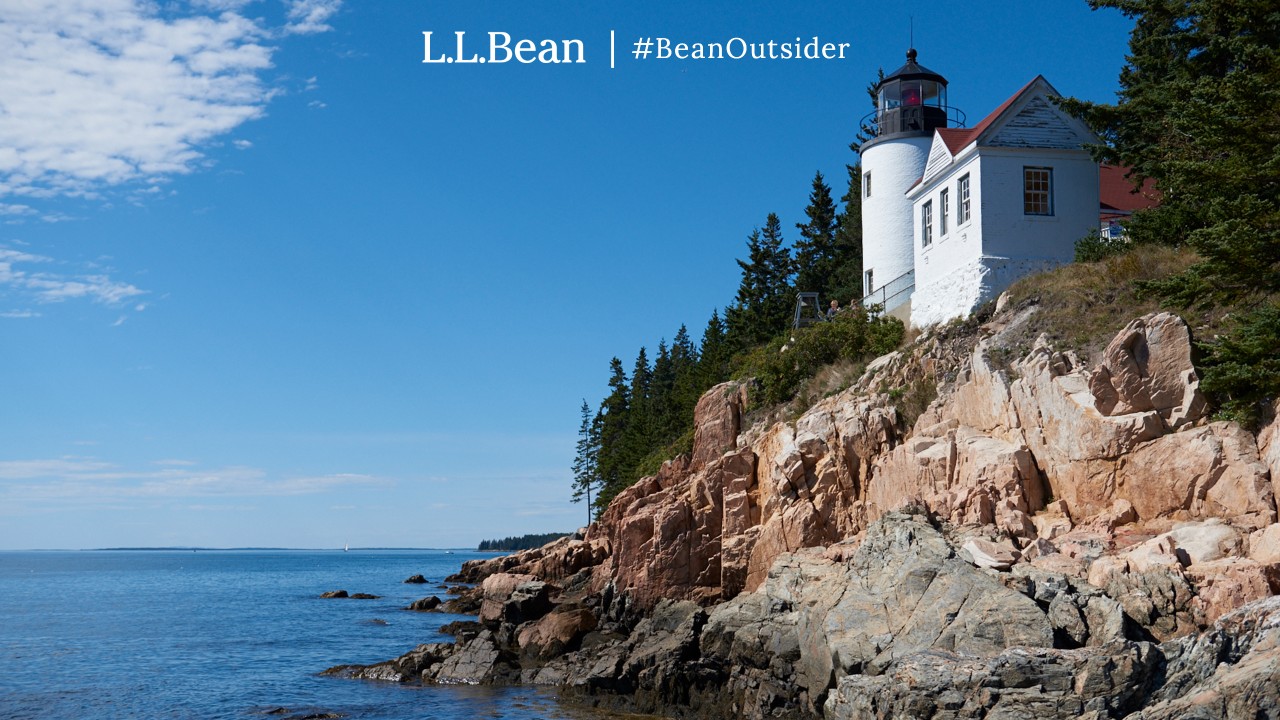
[0,0,340,198]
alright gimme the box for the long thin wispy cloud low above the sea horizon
[0,457,389,502]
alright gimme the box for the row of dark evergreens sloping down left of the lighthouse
[573,161,880,510]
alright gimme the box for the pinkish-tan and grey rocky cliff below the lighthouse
[325,306,1280,719]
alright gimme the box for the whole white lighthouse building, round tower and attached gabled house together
[861,50,1149,327]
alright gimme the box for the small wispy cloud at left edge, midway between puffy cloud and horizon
[0,247,147,307]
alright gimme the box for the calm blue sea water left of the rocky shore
[0,551,614,720]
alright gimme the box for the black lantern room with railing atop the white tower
[868,47,964,138]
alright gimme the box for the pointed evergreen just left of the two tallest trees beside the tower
[726,213,795,347]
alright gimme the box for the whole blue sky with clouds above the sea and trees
[0,0,1132,550]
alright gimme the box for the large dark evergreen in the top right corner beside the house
[1062,0,1280,304]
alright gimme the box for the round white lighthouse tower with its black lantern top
[860,47,964,311]
